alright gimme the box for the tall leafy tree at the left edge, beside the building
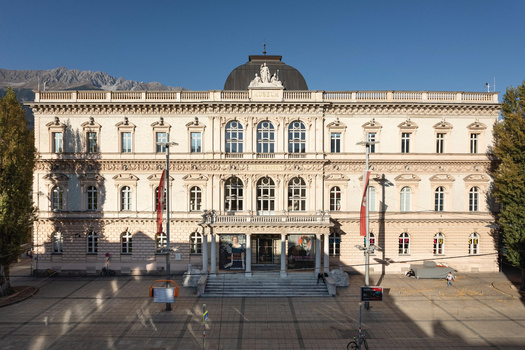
[0,88,35,296]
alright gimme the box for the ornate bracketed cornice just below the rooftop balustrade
[30,102,500,116]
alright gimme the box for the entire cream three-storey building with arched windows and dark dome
[30,56,500,275]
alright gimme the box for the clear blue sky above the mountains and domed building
[0,0,525,92]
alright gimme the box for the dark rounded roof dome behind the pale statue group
[224,55,308,91]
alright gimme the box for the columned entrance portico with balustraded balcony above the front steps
[201,213,333,277]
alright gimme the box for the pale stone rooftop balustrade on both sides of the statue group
[35,91,498,103]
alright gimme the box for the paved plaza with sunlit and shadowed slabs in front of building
[0,258,525,350]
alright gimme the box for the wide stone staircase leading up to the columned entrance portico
[202,271,329,298]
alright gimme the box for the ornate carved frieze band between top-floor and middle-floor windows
[36,159,490,176]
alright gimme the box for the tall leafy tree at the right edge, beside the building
[491,81,525,291]
